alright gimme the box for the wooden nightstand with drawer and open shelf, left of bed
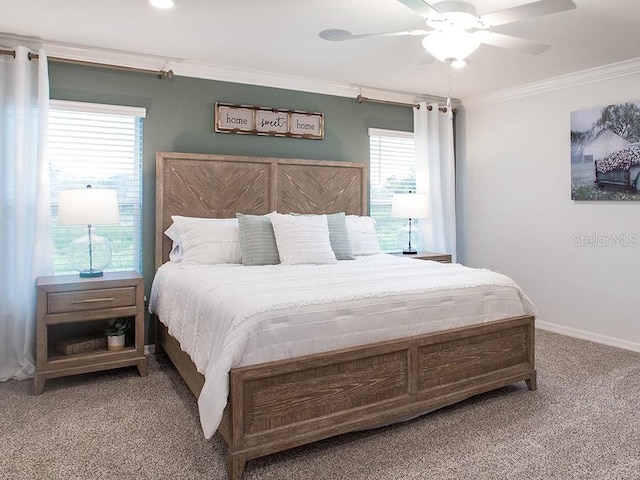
[34,272,147,395]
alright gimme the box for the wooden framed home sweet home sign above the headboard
[214,102,324,140]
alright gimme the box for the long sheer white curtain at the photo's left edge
[0,46,53,381]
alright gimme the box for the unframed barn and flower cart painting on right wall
[571,101,640,200]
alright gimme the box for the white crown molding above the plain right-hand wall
[462,58,640,110]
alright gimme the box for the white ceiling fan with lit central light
[319,0,576,67]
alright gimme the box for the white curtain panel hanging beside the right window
[413,102,456,262]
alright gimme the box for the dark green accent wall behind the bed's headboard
[49,62,413,343]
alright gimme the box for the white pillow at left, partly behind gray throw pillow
[171,215,242,265]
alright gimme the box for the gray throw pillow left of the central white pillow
[236,213,280,265]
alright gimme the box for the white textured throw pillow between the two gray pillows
[270,213,338,265]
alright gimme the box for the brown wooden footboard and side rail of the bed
[156,316,536,480]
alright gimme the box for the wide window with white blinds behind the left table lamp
[49,100,145,274]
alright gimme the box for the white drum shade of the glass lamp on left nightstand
[58,188,120,225]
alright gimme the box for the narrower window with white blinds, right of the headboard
[369,128,418,252]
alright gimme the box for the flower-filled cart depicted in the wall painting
[594,144,640,190]
